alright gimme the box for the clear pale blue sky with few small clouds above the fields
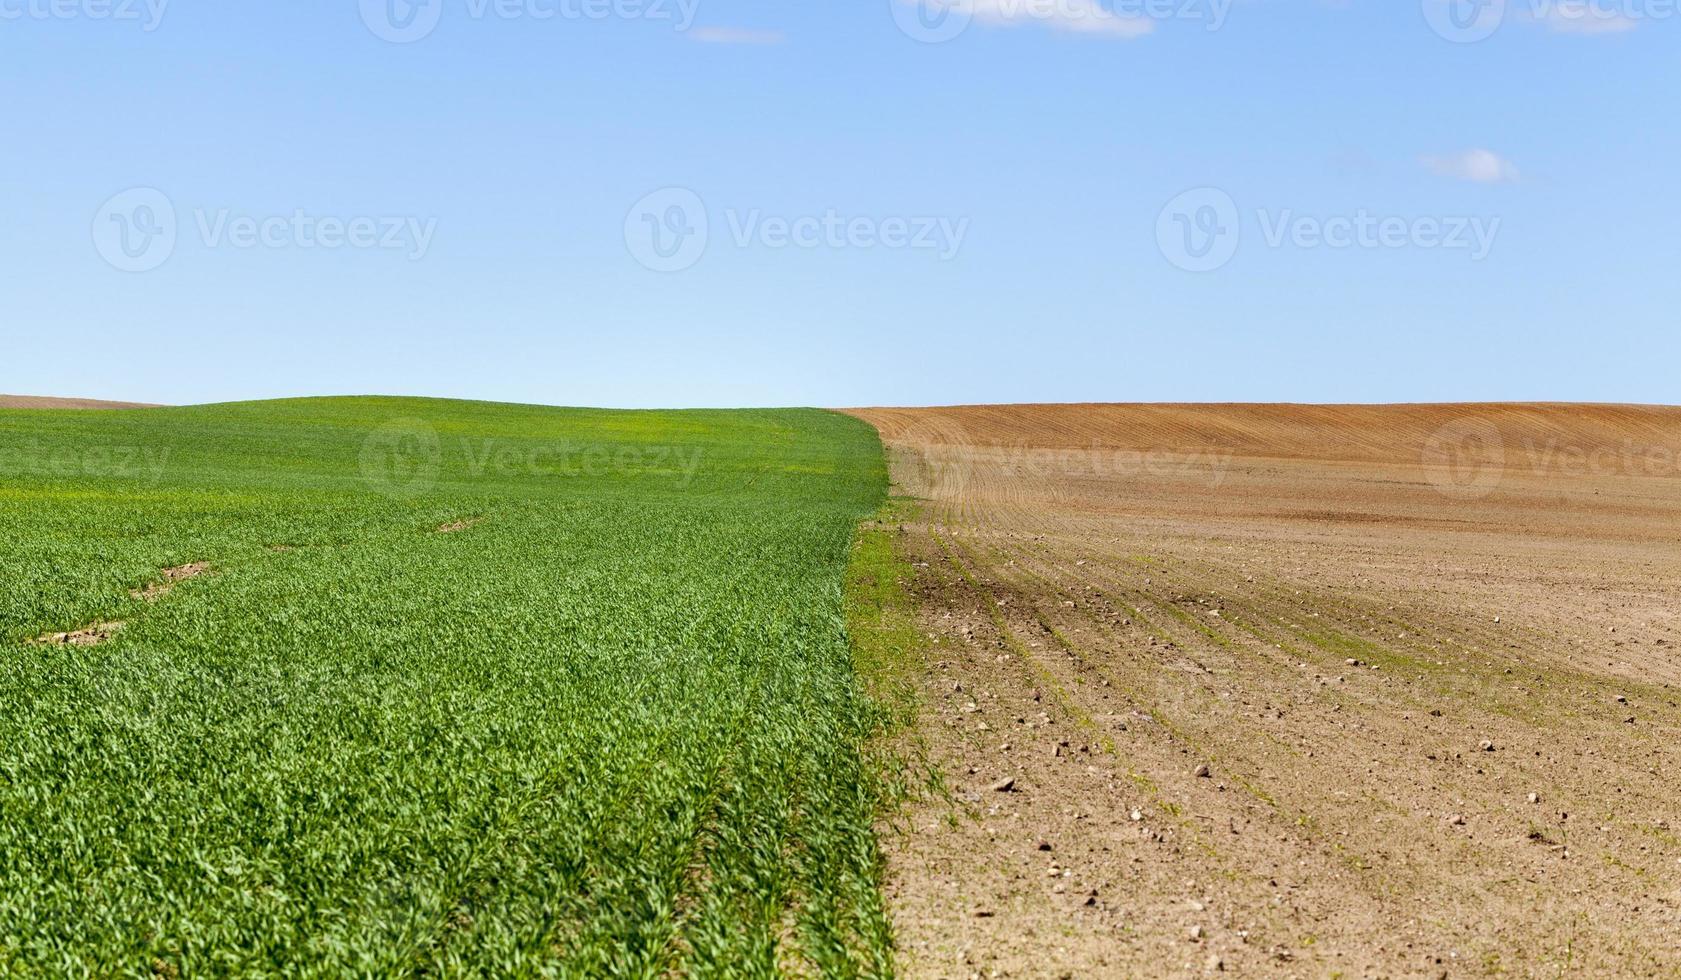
[0,0,1681,407]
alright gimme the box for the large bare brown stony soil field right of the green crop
[856,405,1681,977]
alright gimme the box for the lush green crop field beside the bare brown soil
[0,398,891,977]
